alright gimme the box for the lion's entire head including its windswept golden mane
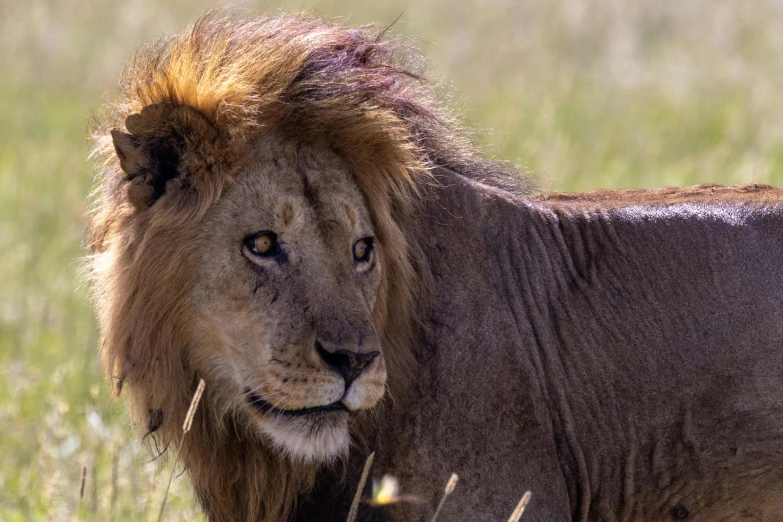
[90,10,524,520]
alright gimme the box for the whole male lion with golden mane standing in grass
[90,15,783,521]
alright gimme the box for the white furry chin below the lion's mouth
[259,412,351,463]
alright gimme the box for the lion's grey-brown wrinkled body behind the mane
[370,176,783,521]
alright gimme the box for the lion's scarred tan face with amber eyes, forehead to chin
[192,137,386,460]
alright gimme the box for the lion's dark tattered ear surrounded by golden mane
[111,103,218,209]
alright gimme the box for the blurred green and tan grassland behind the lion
[0,0,783,521]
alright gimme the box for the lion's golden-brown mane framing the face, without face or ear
[89,13,525,520]
